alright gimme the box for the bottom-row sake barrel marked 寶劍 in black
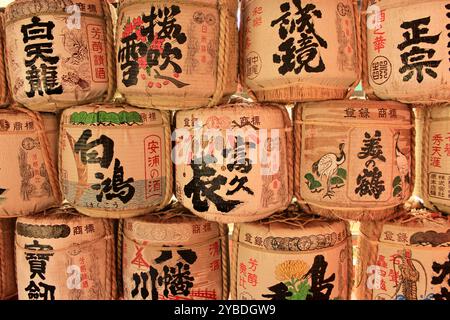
[16,209,116,300]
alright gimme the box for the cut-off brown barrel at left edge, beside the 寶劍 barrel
[0,219,17,300]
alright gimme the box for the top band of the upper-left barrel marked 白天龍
[5,0,104,23]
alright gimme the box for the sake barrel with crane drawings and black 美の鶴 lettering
[294,100,415,220]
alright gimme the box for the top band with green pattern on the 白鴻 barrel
[62,103,164,128]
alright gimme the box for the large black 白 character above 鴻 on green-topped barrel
[74,129,114,169]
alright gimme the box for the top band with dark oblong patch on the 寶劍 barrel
[16,208,113,250]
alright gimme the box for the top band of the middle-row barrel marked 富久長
[176,103,291,130]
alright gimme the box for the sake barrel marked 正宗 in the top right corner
[362,0,450,104]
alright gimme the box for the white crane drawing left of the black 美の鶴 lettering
[312,143,346,199]
